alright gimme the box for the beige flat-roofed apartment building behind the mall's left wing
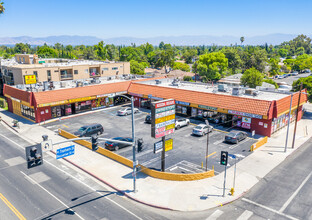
[0,54,130,85]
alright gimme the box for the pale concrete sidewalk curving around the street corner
[0,104,312,211]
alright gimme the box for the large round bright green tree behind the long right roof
[197,52,228,80]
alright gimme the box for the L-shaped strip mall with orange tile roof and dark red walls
[3,77,307,137]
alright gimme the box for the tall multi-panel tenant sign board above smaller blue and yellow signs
[151,99,175,138]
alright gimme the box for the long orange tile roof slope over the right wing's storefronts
[128,83,272,115]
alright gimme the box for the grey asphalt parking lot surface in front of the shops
[43,106,257,174]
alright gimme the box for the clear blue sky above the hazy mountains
[0,0,312,39]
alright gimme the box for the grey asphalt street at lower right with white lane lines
[202,139,312,220]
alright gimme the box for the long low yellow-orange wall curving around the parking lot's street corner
[58,129,214,181]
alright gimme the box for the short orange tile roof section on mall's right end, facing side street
[276,89,308,115]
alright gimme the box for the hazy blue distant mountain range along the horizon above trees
[0,34,312,46]
